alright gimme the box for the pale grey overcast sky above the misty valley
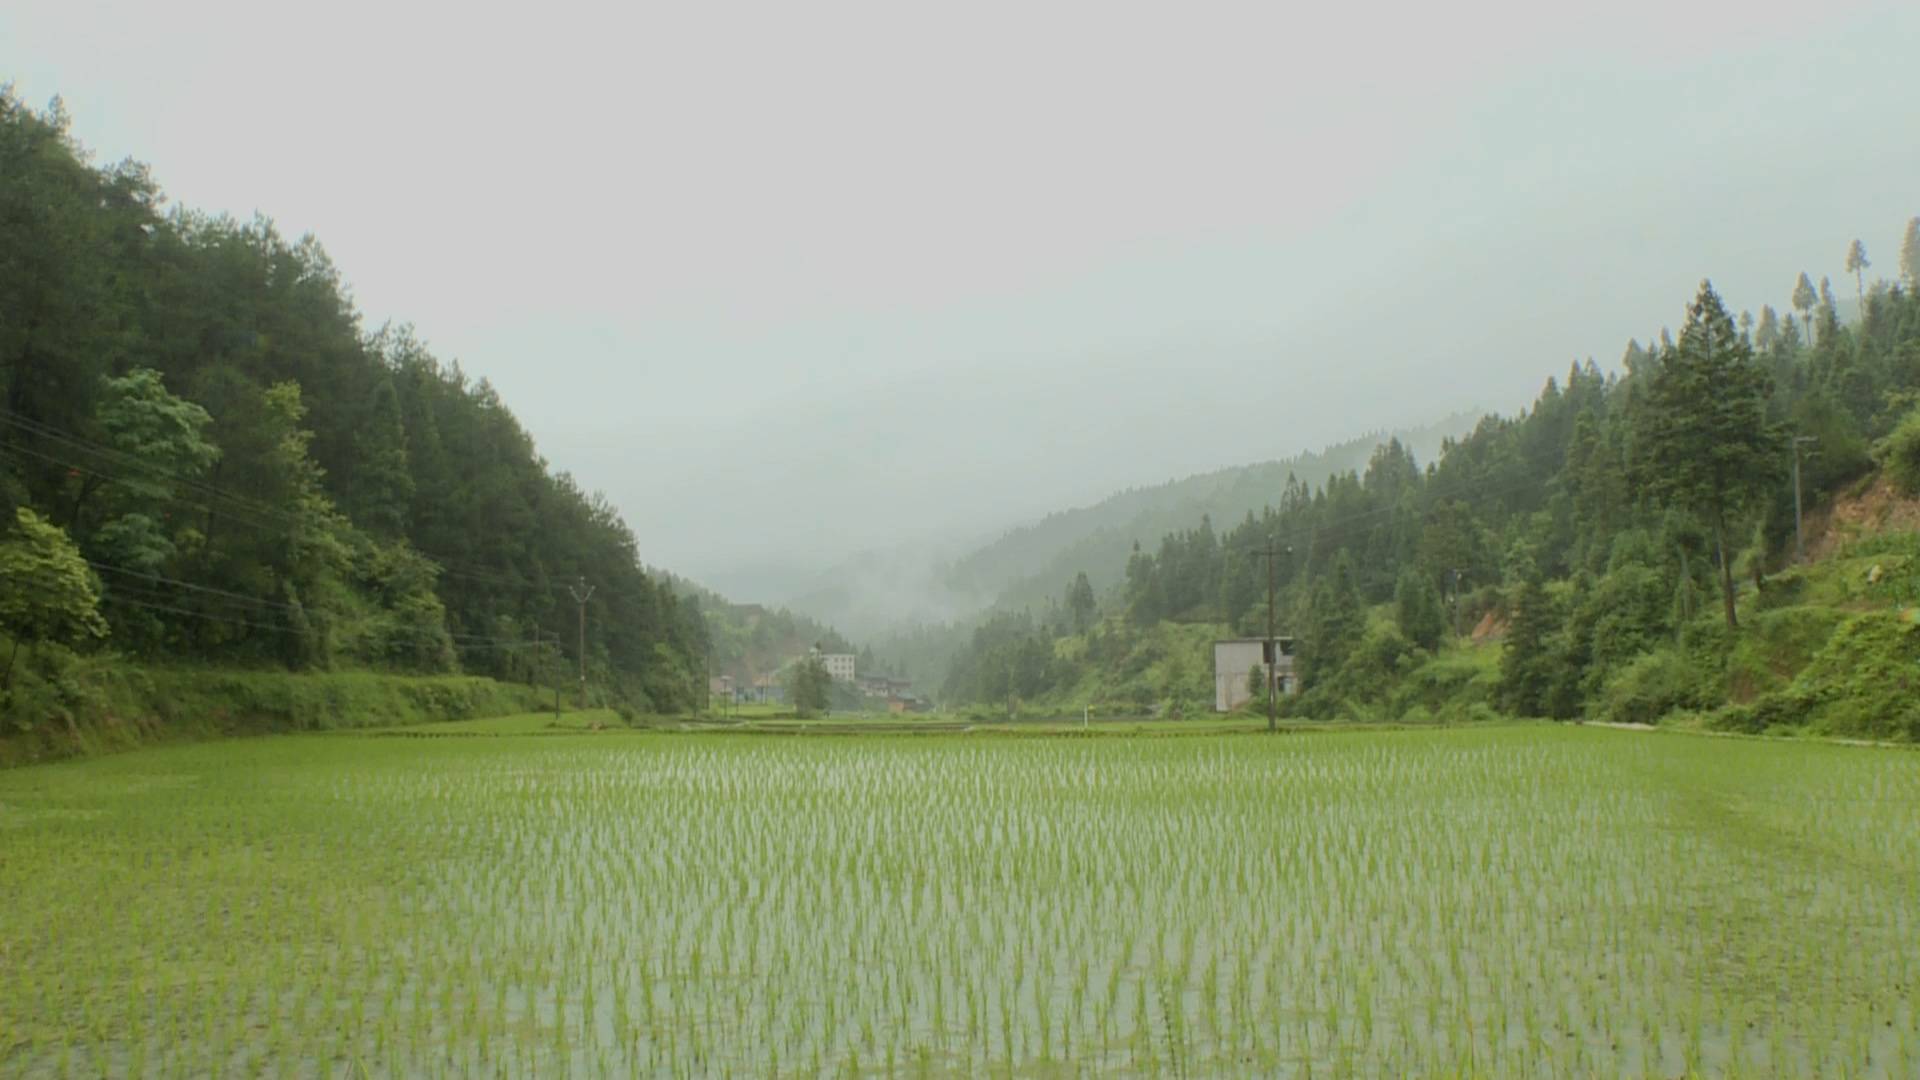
[0,0,1920,600]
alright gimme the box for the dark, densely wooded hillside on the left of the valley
[0,90,707,723]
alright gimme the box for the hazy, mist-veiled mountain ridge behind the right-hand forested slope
[787,413,1478,642]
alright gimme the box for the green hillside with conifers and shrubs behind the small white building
[947,219,1920,738]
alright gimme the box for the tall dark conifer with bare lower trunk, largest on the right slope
[1640,281,1780,626]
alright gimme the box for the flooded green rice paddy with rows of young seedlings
[0,726,1920,1076]
